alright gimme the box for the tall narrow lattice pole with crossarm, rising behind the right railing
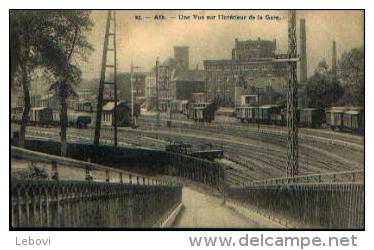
[287,10,299,178]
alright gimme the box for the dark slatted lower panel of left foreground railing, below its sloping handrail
[11,180,182,228]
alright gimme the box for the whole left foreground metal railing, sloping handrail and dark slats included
[10,147,182,228]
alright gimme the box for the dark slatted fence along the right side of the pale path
[227,182,364,229]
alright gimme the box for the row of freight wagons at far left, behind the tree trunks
[11,107,91,128]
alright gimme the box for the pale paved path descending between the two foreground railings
[175,187,281,228]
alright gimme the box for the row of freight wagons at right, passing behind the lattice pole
[235,105,365,133]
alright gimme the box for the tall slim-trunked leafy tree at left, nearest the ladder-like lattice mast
[40,10,93,156]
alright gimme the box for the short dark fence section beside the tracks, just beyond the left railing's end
[165,152,225,192]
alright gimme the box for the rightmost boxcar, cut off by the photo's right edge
[343,108,365,133]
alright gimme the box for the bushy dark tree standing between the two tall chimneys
[306,60,344,108]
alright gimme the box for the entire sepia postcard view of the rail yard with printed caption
[9,9,365,230]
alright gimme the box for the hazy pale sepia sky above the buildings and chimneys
[82,10,364,79]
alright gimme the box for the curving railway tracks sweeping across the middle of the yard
[11,121,364,185]
